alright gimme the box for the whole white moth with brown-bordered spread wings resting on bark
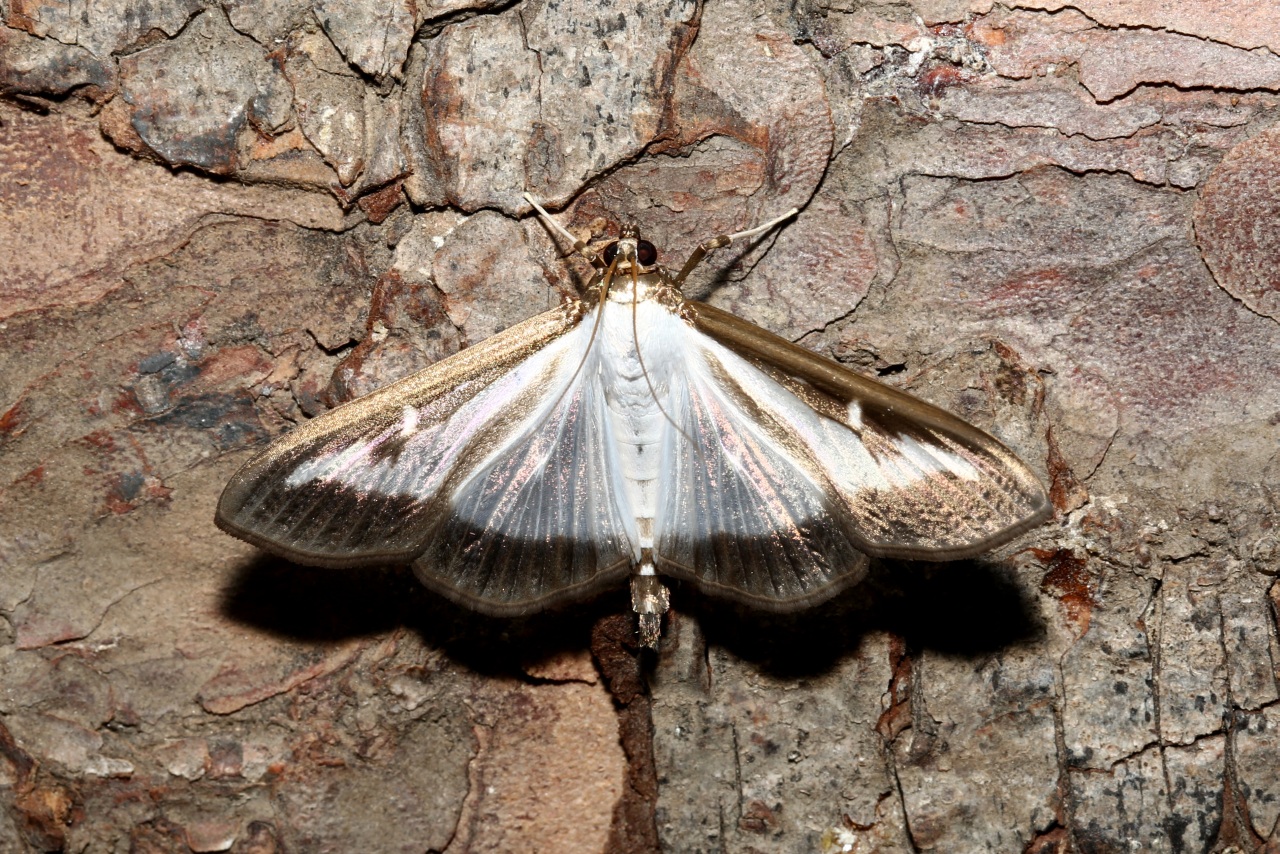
[216,195,1051,647]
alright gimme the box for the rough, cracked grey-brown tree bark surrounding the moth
[0,0,1280,854]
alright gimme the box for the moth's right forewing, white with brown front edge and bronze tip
[690,303,1052,560]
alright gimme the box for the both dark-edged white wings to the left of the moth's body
[216,303,630,613]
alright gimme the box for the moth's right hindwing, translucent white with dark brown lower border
[654,311,867,609]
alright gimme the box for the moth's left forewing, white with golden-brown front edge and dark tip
[216,303,581,566]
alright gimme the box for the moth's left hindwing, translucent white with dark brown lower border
[413,320,639,613]
